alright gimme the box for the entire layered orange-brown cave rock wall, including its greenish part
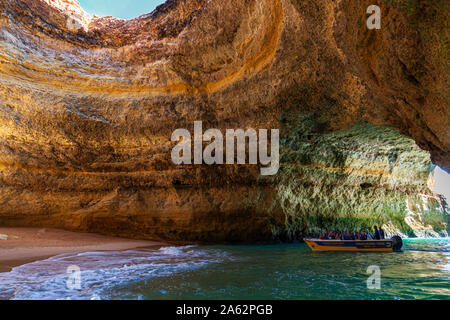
[0,0,450,242]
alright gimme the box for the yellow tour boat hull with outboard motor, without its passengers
[305,236,403,252]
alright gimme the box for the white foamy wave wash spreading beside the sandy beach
[0,246,227,300]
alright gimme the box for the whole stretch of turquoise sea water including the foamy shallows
[0,239,450,300]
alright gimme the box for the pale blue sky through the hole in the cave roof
[78,0,165,19]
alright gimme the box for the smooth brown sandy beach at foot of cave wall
[0,228,165,272]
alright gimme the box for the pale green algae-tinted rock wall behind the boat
[268,120,449,237]
